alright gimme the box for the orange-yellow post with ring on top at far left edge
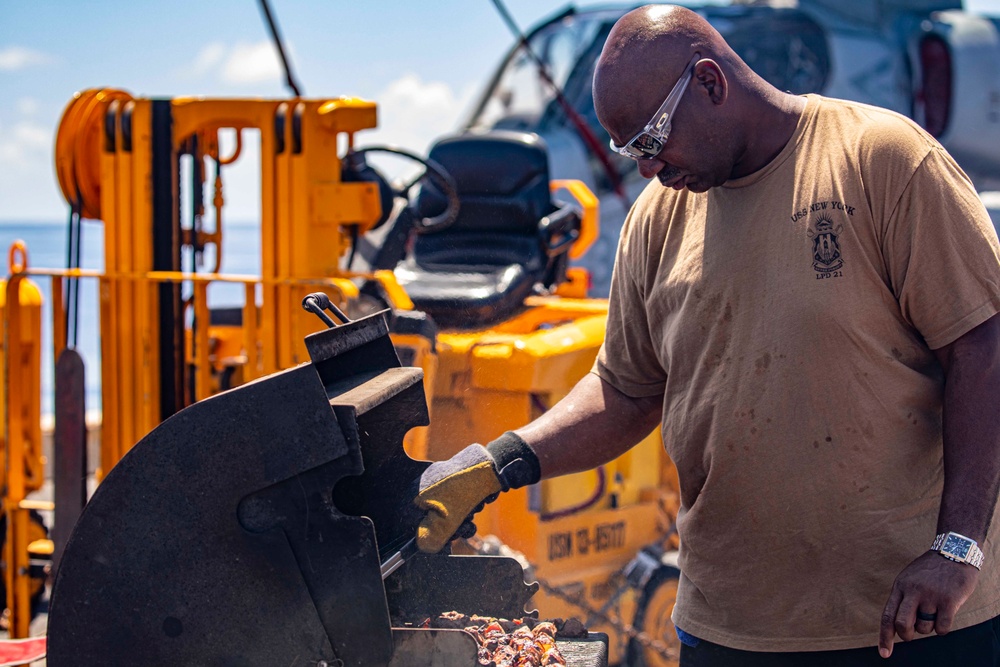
[0,241,42,638]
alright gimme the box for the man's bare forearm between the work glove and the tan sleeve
[514,373,663,479]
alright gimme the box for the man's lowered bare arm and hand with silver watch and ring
[879,315,1000,658]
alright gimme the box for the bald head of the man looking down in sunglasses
[594,5,801,191]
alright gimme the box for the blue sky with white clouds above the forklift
[0,0,1000,220]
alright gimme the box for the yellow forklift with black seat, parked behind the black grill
[3,89,678,665]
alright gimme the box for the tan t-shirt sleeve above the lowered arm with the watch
[883,146,1000,349]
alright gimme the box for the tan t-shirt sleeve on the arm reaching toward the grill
[591,199,667,398]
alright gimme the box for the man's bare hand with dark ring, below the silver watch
[878,551,979,658]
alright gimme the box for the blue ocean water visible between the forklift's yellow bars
[0,220,261,415]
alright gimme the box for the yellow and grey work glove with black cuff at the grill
[413,432,540,553]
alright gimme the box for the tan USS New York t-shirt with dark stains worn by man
[594,96,1000,651]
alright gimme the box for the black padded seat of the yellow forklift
[396,131,581,328]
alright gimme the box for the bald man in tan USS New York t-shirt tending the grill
[417,7,1000,666]
